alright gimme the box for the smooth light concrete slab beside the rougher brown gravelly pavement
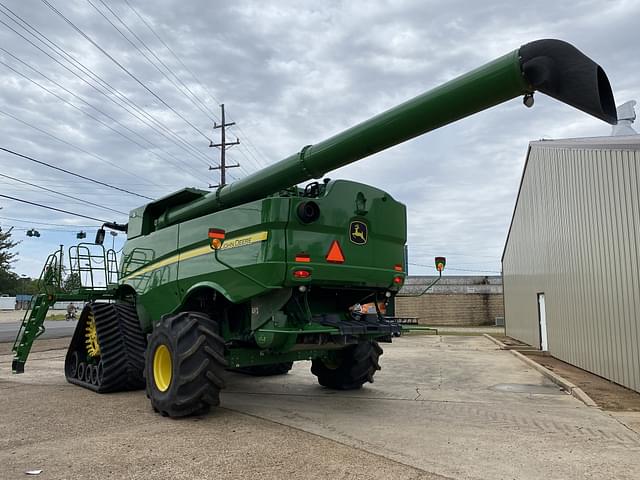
[223,336,640,480]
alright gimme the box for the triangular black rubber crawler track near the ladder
[65,302,147,393]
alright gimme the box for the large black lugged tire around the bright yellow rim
[145,312,227,417]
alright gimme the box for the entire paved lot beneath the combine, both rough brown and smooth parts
[0,336,640,480]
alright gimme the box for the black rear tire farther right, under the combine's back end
[311,341,382,390]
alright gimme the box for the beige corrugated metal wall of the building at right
[503,136,640,391]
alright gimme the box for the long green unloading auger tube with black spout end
[156,40,617,228]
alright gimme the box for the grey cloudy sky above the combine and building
[0,0,640,275]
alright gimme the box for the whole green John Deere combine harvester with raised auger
[13,40,616,417]
